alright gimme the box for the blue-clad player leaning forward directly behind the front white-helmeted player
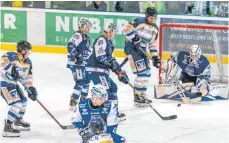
[86,23,129,121]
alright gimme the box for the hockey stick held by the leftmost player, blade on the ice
[17,81,74,130]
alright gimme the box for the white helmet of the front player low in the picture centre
[91,84,108,102]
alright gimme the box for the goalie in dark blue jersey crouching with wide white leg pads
[155,45,229,102]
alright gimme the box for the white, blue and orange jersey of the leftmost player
[0,52,32,87]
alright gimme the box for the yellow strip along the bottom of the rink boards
[0,43,229,64]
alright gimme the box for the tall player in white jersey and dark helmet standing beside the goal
[123,8,160,106]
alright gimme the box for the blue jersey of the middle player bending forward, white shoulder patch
[87,35,114,70]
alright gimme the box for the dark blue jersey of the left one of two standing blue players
[67,31,92,68]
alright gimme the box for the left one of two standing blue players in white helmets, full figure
[67,19,92,111]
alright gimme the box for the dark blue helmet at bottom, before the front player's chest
[88,115,107,136]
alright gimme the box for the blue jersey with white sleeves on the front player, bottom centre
[72,99,124,143]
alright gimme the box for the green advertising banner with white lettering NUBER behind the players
[45,12,136,49]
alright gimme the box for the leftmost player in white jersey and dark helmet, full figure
[0,41,37,137]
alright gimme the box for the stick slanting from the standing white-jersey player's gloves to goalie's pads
[138,47,202,103]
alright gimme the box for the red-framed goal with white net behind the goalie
[159,23,228,83]
